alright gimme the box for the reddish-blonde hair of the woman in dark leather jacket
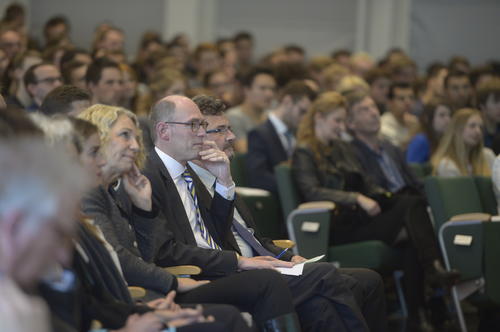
[297,91,346,166]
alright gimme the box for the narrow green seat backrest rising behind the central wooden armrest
[274,163,300,220]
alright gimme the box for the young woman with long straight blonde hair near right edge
[431,108,495,176]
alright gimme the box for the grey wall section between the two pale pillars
[216,0,356,55]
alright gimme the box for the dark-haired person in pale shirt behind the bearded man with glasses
[227,68,276,153]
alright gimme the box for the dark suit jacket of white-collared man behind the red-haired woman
[245,119,288,194]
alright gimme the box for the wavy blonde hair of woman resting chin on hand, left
[78,104,146,169]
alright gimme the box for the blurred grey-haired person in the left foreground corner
[0,137,85,331]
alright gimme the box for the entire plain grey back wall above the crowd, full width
[0,0,500,69]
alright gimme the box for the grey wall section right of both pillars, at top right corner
[410,0,500,65]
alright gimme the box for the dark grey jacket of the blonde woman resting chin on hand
[82,186,177,294]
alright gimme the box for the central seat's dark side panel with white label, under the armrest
[287,209,331,258]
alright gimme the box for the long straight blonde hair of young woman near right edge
[431,108,491,176]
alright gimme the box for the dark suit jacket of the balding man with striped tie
[144,150,238,277]
